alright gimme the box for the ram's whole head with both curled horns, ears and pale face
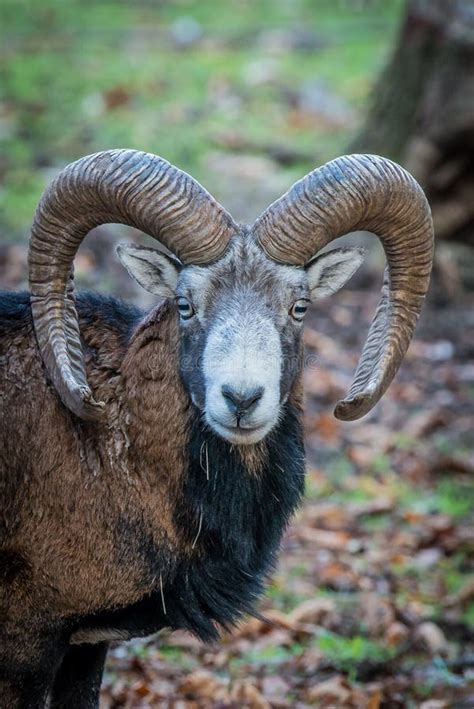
[30,150,433,443]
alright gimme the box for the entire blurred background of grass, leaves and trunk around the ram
[0,0,474,709]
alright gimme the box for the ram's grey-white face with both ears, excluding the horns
[116,234,362,444]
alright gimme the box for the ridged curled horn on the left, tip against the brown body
[28,150,237,419]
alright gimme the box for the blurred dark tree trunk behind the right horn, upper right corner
[351,0,474,245]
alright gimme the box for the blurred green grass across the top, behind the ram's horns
[0,0,402,240]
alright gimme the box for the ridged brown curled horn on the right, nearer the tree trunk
[254,155,433,421]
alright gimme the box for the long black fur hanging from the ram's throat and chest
[165,404,304,640]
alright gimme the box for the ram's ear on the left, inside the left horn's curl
[117,244,182,298]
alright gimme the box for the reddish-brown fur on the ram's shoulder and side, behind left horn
[0,298,190,624]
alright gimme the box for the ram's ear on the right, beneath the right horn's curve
[306,248,367,300]
